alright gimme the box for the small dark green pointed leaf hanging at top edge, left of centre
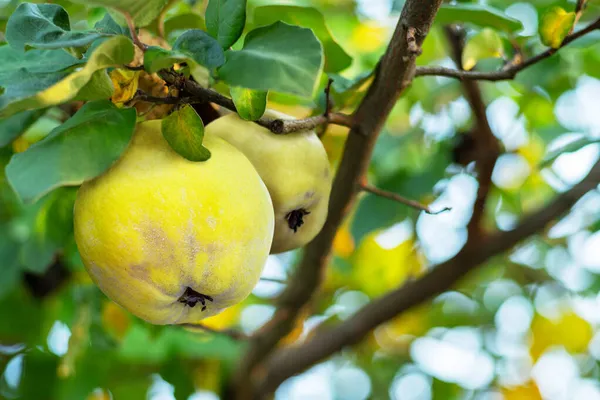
[206,0,246,49]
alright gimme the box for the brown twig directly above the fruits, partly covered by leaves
[159,71,352,134]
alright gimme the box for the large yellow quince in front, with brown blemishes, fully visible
[74,120,274,325]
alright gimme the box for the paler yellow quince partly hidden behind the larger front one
[206,110,332,254]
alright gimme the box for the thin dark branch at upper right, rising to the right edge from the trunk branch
[415,19,600,81]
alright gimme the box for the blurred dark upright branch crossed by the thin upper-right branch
[446,27,500,238]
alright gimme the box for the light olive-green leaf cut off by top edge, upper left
[71,0,169,28]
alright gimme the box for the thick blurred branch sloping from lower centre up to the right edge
[262,158,600,392]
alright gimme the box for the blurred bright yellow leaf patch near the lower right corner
[529,310,594,360]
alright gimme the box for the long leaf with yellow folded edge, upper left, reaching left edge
[0,36,134,118]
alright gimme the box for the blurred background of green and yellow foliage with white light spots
[0,0,600,400]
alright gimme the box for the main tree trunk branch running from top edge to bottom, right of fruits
[233,0,442,399]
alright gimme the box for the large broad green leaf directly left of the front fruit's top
[6,100,136,202]
